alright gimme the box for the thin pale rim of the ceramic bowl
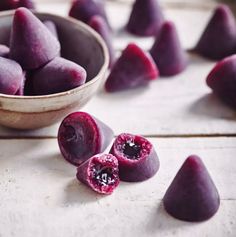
[0,10,109,100]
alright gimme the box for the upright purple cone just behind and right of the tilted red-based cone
[150,21,188,76]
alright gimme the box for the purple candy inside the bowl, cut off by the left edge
[0,57,24,95]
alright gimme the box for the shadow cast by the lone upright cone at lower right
[147,202,195,236]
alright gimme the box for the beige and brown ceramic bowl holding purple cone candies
[0,11,109,129]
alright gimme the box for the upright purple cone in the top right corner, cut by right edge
[195,4,236,60]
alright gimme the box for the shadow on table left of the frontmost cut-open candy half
[64,179,105,206]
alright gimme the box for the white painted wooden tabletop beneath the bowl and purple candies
[0,0,236,237]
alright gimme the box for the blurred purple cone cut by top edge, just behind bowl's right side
[69,0,108,24]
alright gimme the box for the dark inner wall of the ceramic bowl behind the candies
[0,11,105,82]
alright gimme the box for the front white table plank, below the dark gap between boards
[0,138,236,237]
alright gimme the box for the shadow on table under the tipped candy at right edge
[189,93,236,120]
